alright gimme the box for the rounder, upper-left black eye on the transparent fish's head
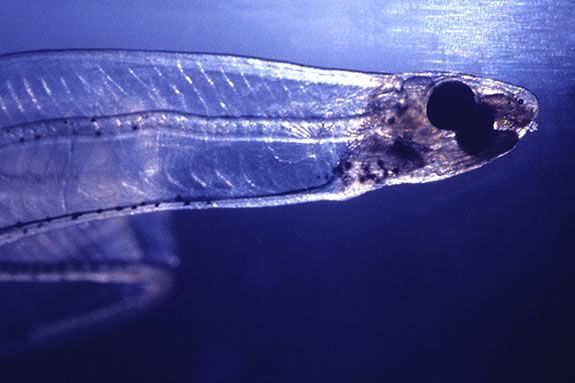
[427,81,475,131]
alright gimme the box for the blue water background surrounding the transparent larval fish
[0,0,575,382]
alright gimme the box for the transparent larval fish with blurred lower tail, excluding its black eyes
[0,51,538,352]
